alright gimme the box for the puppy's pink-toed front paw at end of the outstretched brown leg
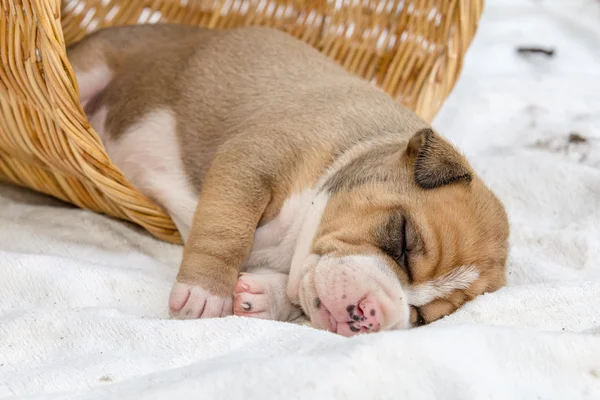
[169,282,232,319]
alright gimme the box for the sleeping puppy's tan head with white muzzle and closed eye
[298,129,509,336]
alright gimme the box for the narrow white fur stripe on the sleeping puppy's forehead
[406,265,479,307]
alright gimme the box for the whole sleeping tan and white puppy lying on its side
[68,24,509,336]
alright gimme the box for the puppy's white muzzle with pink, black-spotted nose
[298,255,410,336]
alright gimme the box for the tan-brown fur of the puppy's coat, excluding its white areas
[68,25,508,322]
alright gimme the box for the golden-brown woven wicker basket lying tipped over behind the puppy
[0,0,483,243]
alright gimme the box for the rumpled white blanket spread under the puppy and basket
[0,0,600,400]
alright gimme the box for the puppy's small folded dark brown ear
[406,128,473,189]
